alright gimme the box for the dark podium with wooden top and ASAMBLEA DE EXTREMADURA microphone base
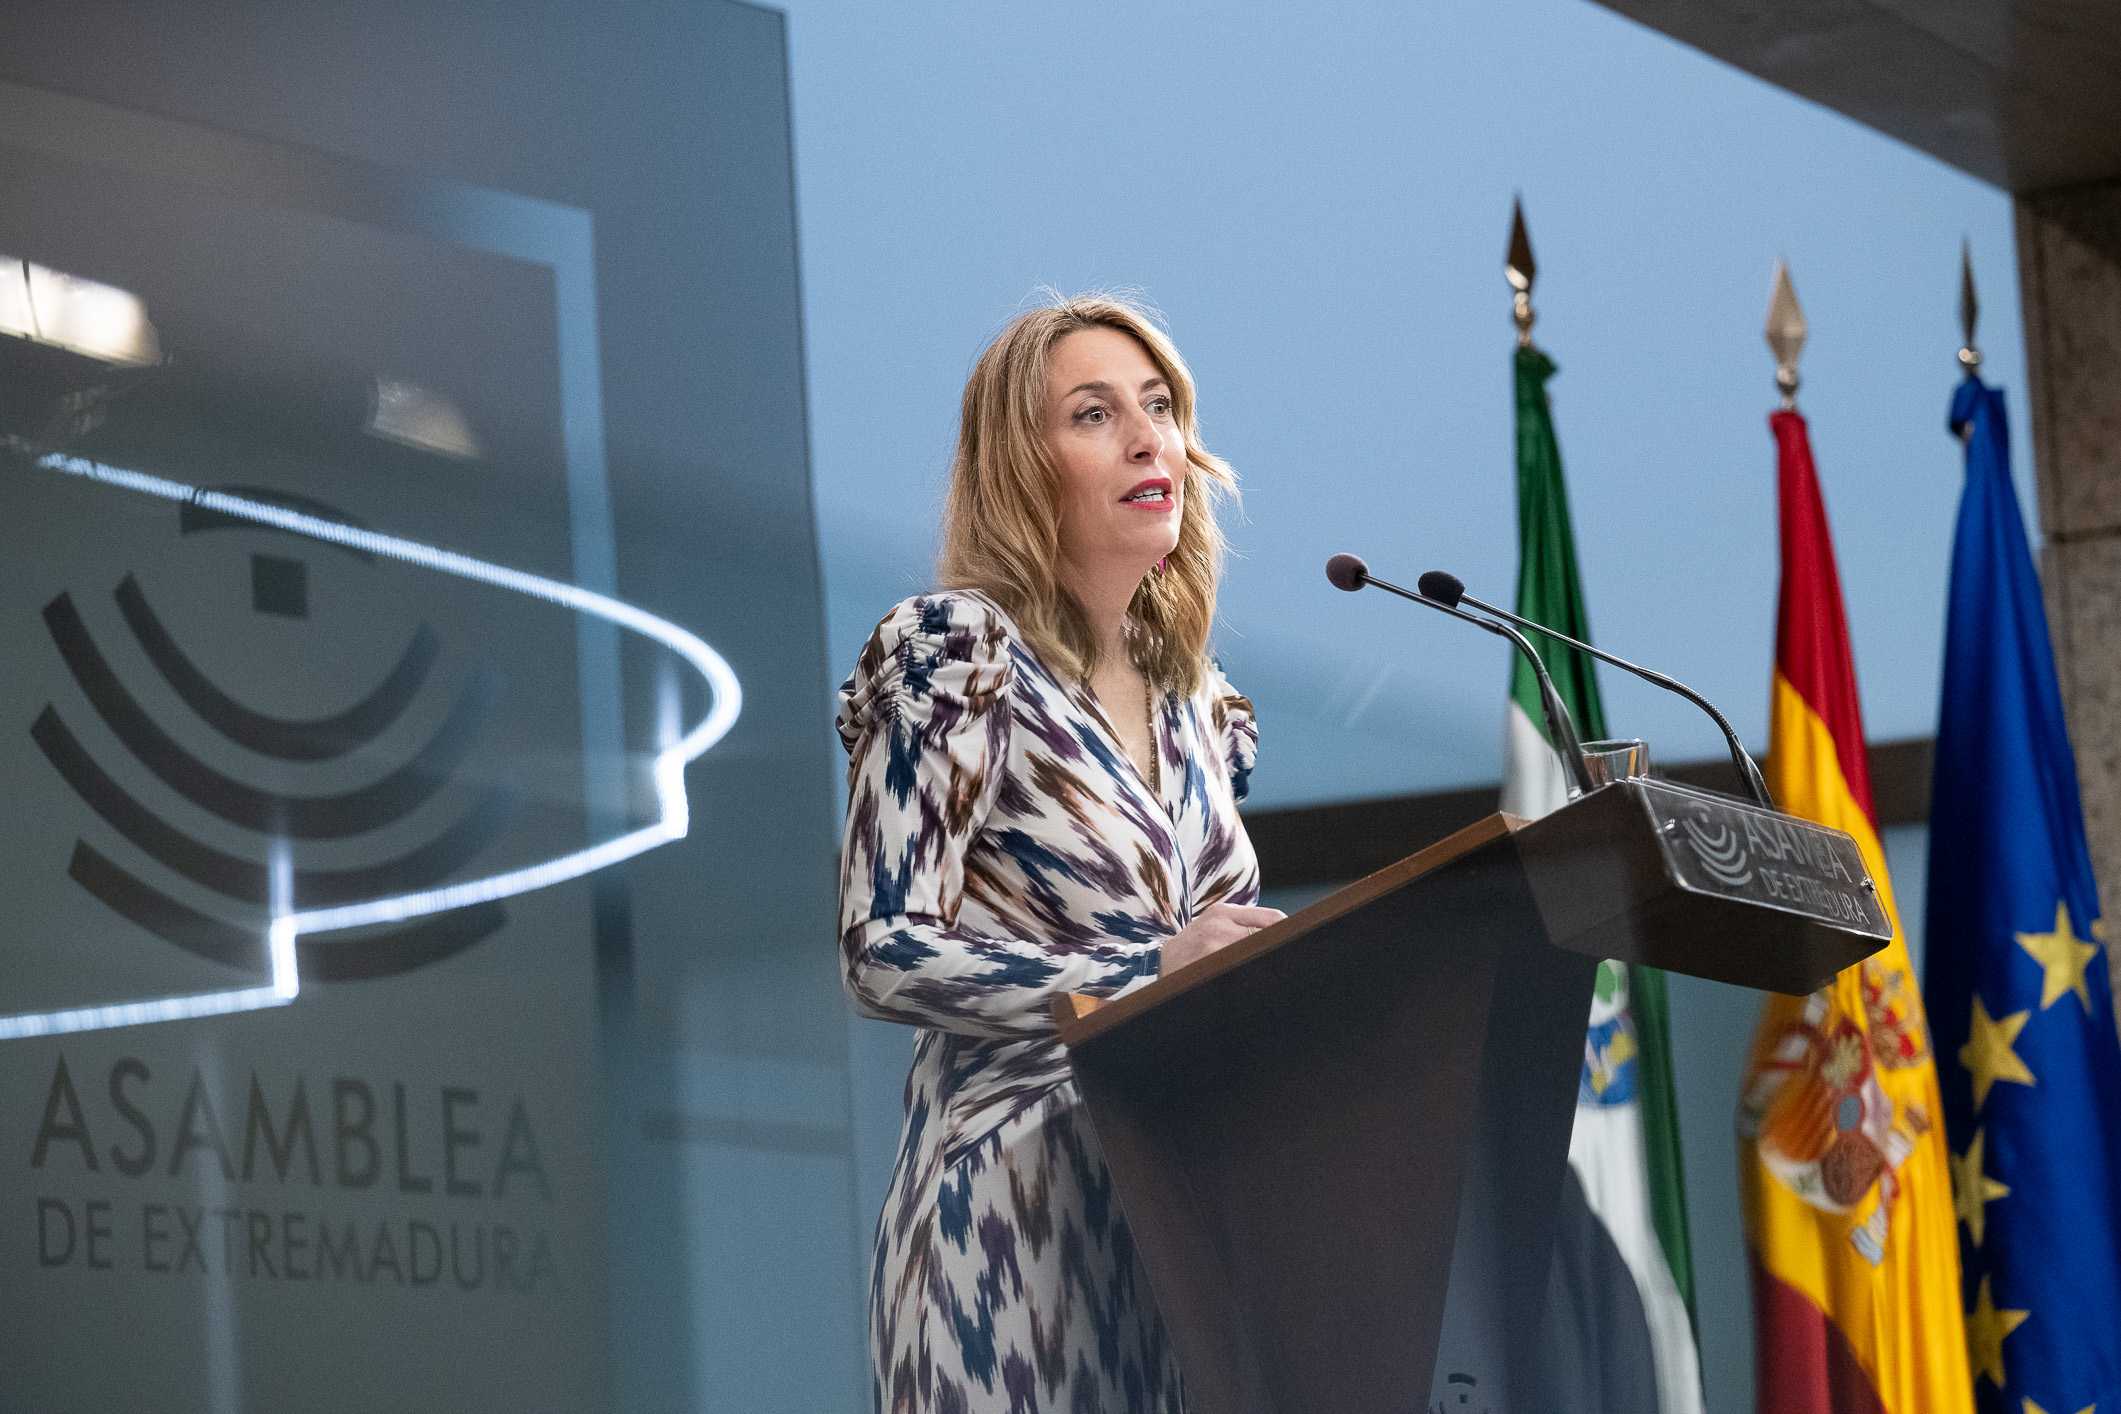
[1054,778,1892,1414]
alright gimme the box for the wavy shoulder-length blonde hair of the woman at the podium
[937,293,1237,695]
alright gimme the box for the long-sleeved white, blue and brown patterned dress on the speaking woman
[840,594,1260,1414]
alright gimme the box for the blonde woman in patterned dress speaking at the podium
[838,297,1281,1414]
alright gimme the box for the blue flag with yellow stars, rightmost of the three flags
[1926,377,2121,1414]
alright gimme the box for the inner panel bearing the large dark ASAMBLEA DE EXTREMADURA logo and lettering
[0,132,615,1410]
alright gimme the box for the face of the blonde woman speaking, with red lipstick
[1046,329,1186,583]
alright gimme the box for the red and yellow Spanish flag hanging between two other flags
[1737,411,1973,1414]
